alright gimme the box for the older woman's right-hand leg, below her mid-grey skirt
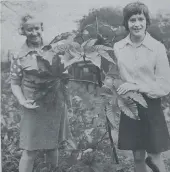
[46,148,58,167]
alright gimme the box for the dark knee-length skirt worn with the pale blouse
[118,96,170,153]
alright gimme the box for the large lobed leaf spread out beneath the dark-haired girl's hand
[97,66,147,125]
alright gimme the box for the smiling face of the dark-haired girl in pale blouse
[128,13,146,38]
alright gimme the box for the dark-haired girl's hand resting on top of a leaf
[117,82,139,94]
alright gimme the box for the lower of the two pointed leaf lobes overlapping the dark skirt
[117,98,139,120]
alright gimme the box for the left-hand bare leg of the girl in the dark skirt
[133,150,147,172]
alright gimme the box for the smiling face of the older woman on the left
[23,22,42,44]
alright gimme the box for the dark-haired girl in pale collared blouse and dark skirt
[109,2,170,172]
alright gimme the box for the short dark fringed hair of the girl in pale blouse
[123,2,151,31]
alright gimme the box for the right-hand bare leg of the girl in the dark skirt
[148,153,166,172]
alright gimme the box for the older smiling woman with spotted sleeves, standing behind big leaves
[11,15,69,172]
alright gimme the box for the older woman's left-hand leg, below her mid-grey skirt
[19,150,37,172]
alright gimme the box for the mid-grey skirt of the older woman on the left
[20,87,71,150]
